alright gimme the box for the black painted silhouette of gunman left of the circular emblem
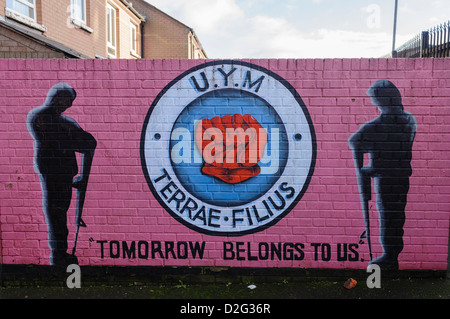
[27,82,97,266]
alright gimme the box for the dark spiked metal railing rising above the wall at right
[387,21,450,58]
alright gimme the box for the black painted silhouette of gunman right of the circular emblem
[348,80,417,270]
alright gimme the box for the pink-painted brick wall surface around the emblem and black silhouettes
[0,59,450,270]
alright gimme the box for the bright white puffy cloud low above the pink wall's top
[209,15,409,58]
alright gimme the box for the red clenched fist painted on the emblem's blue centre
[195,114,268,184]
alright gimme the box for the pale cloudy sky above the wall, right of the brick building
[144,0,450,59]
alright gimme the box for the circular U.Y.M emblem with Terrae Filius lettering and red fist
[141,61,316,236]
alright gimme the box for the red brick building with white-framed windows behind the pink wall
[0,0,206,59]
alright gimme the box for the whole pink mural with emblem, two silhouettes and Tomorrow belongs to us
[4,59,450,270]
